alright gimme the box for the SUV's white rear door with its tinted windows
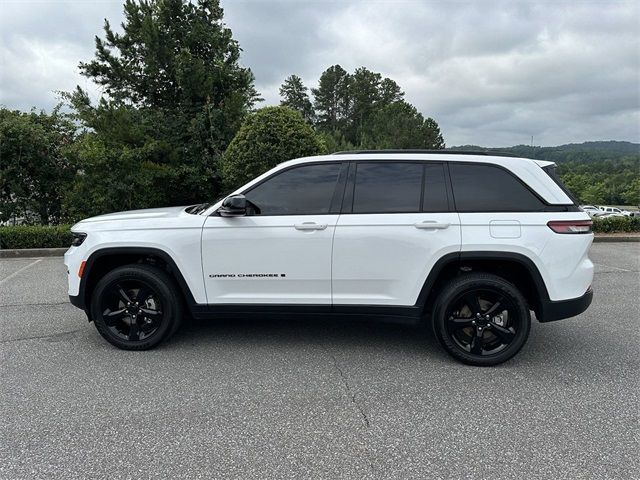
[332,160,460,306]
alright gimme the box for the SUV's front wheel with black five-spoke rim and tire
[91,264,183,350]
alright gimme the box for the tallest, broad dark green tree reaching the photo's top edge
[66,0,258,216]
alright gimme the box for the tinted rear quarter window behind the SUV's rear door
[449,162,545,212]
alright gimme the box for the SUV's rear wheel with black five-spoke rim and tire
[432,273,531,366]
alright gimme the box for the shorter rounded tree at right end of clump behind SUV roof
[363,102,445,149]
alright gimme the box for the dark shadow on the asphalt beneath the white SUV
[160,316,613,369]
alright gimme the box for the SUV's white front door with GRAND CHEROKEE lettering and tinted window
[202,162,344,304]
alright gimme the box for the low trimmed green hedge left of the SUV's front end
[0,225,72,249]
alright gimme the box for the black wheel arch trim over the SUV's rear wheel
[416,251,549,316]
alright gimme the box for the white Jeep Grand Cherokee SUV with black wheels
[65,151,593,365]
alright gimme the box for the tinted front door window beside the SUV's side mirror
[245,163,340,215]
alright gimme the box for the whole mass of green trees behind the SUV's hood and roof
[0,0,444,224]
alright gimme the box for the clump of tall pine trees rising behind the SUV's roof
[280,65,445,151]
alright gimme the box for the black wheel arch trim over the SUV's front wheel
[78,247,196,315]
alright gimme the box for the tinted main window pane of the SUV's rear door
[353,162,423,213]
